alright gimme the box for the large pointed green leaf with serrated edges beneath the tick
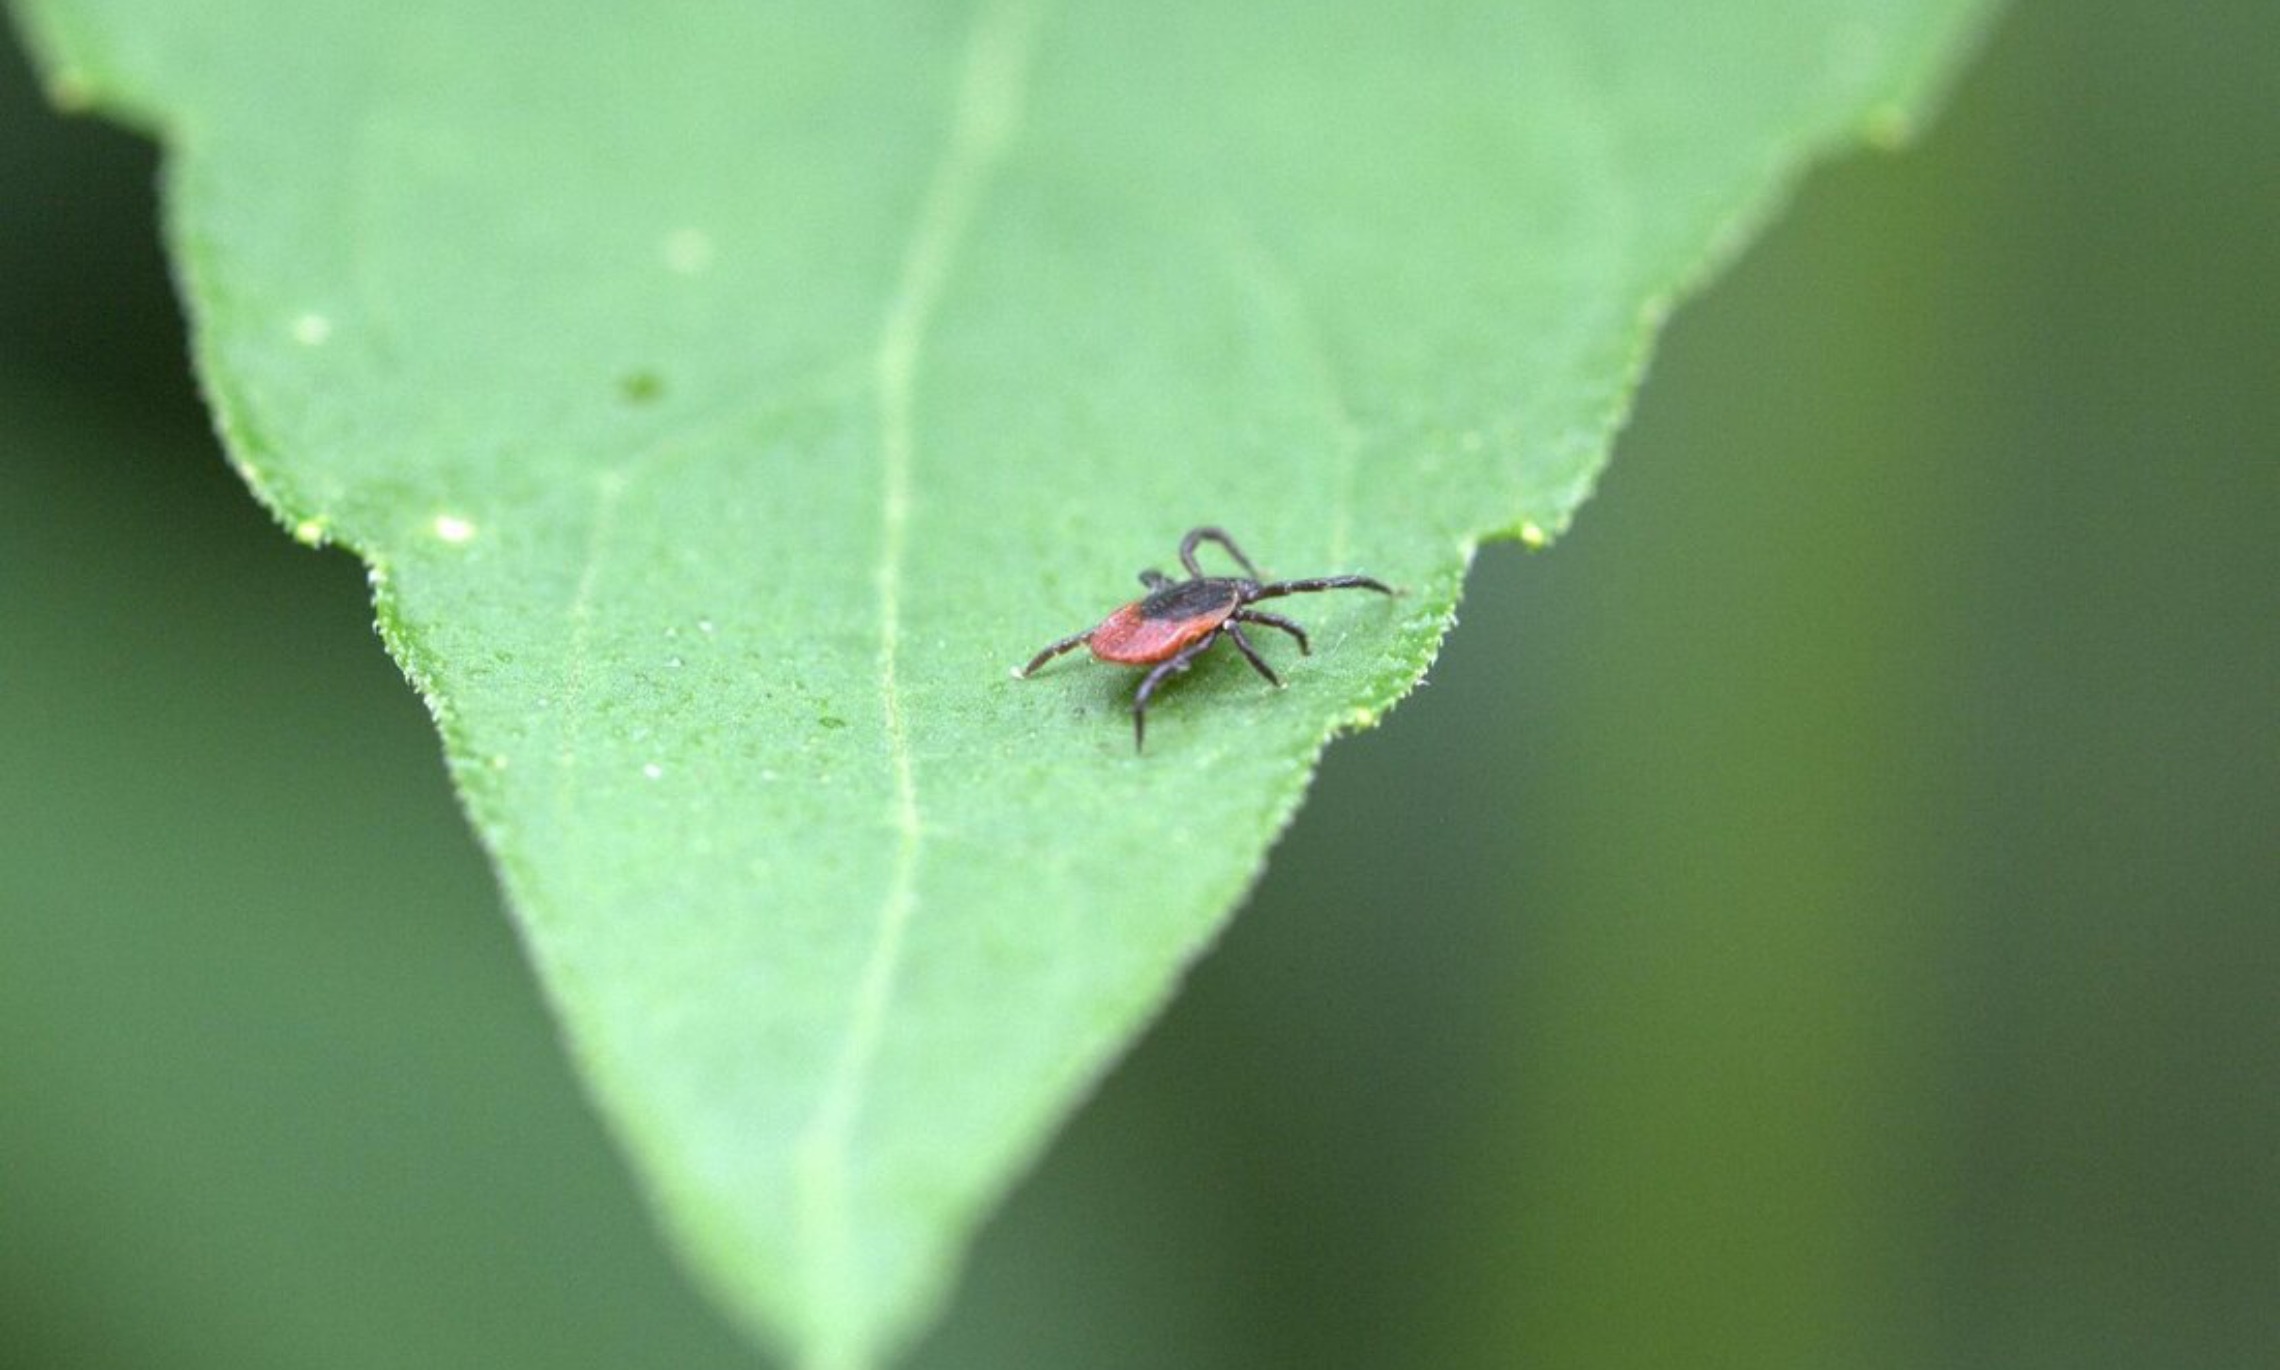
[18,0,1977,1365]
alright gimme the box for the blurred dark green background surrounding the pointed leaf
[0,0,2280,1370]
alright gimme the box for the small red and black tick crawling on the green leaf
[1015,529,1393,752]
